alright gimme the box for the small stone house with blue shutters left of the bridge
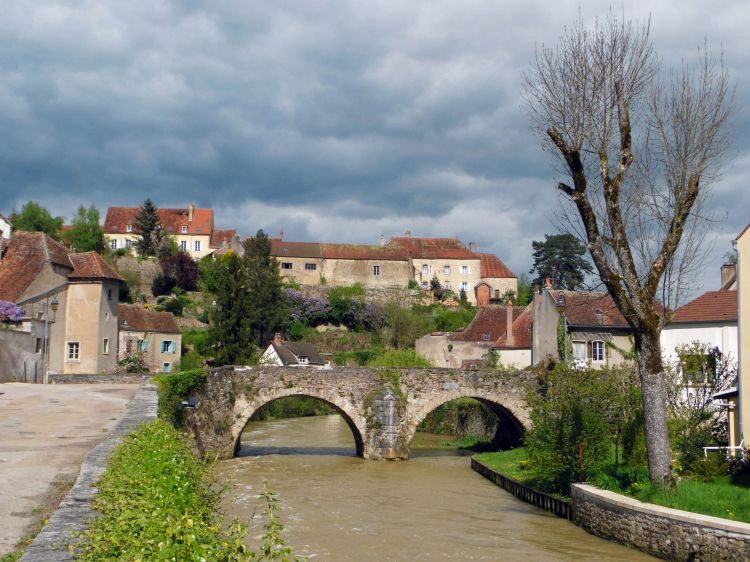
[117,304,182,373]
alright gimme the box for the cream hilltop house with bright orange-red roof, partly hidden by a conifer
[102,203,239,260]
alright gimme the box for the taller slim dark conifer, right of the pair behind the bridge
[243,230,288,347]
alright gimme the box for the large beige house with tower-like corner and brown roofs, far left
[0,231,122,382]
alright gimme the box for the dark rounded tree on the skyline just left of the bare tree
[529,234,593,291]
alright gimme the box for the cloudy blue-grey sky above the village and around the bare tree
[0,0,750,289]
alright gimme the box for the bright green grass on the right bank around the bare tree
[474,447,750,523]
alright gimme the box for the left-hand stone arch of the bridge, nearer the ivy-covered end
[232,387,366,457]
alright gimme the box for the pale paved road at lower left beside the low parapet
[0,383,138,556]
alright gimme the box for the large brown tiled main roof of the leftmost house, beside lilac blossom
[0,230,73,302]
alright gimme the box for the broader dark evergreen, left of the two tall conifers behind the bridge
[208,252,255,365]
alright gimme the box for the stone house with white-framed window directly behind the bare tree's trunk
[531,280,633,369]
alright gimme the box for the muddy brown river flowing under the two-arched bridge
[217,415,651,562]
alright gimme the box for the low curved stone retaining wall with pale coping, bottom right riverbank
[571,484,750,561]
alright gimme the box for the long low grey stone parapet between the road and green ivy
[21,382,158,562]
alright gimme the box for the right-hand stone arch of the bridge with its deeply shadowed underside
[406,388,529,448]
